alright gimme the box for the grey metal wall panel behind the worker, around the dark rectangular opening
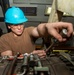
[9,0,53,23]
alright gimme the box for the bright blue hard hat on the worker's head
[5,6,28,24]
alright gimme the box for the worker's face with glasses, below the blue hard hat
[8,23,24,36]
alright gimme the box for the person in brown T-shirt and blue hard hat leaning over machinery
[0,7,73,57]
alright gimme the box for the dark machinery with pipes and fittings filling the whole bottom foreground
[0,52,74,75]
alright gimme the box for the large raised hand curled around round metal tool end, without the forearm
[46,22,73,42]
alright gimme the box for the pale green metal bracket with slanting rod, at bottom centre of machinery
[34,55,50,75]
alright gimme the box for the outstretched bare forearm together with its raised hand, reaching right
[34,22,73,42]
